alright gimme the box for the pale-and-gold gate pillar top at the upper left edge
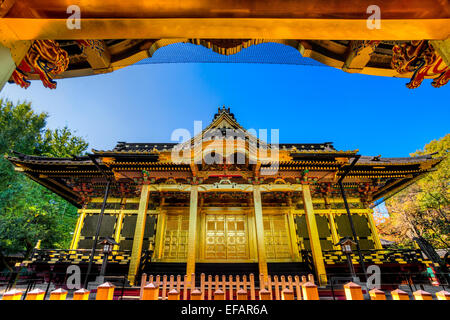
[0,41,31,91]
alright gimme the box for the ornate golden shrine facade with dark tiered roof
[9,107,440,284]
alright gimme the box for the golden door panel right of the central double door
[263,214,292,261]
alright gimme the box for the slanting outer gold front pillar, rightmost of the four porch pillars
[302,184,327,285]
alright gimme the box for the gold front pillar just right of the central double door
[253,185,267,279]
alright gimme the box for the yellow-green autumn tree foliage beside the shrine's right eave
[378,134,450,248]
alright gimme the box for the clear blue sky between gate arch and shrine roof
[0,63,450,157]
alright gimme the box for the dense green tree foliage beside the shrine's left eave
[0,99,88,264]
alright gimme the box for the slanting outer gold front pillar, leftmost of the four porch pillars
[128,184,150,285]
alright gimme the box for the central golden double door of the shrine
[205,214,250,260]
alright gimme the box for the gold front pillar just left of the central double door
[186,186,198,281]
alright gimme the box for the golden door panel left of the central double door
[163,215,189,261]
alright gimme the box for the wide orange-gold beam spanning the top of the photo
[0,18,450,40]
